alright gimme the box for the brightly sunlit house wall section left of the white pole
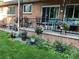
[0,5,17,24]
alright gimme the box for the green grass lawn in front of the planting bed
[0,31,79,59]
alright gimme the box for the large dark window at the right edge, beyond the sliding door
[65,5,79,18]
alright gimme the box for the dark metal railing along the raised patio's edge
[0,17,79,34]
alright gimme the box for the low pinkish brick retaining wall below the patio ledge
[28,32,79,47]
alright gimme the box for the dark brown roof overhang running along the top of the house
[0,0,79,6]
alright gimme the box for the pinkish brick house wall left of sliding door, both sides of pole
[0,3,41,24]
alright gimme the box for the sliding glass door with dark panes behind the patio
[42,6,59,22]
